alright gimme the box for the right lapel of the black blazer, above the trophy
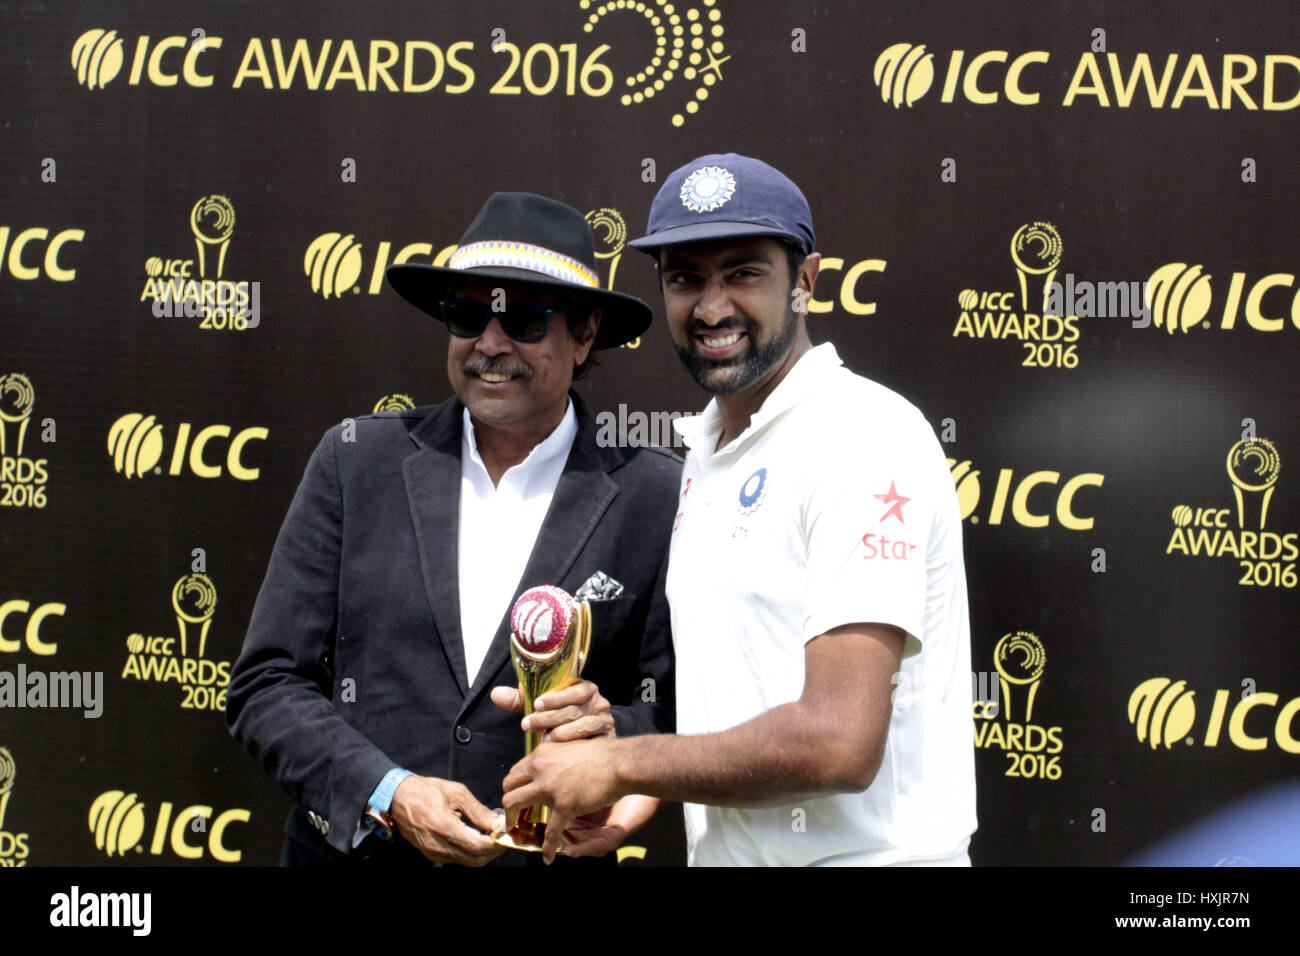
[465,392,623,709]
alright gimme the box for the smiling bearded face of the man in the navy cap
[659,238,811,395]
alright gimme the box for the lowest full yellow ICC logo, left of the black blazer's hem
[86,790,252,864]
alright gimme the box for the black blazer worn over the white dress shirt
[226,393,681,865]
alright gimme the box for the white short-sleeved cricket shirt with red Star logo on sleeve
[667,343,975,866]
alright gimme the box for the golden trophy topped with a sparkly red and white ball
[491,584,592,853]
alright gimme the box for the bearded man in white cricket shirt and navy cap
[504,153,975,865]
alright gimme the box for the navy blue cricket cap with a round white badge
[628,152,816,255]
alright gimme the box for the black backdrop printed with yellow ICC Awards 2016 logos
[0,0,1300,865]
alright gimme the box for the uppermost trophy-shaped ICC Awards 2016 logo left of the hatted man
[140,194,261,332]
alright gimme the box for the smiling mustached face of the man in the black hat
[447,280,594,432]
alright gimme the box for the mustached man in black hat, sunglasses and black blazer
[226,193,681,865]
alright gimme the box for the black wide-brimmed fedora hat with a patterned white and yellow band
[385,193,653,349]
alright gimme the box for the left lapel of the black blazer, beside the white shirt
[402,401,468,696]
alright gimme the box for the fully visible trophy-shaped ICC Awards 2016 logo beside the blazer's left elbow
[122,574,230,710]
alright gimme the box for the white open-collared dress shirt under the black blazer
[458,401,577,685]
